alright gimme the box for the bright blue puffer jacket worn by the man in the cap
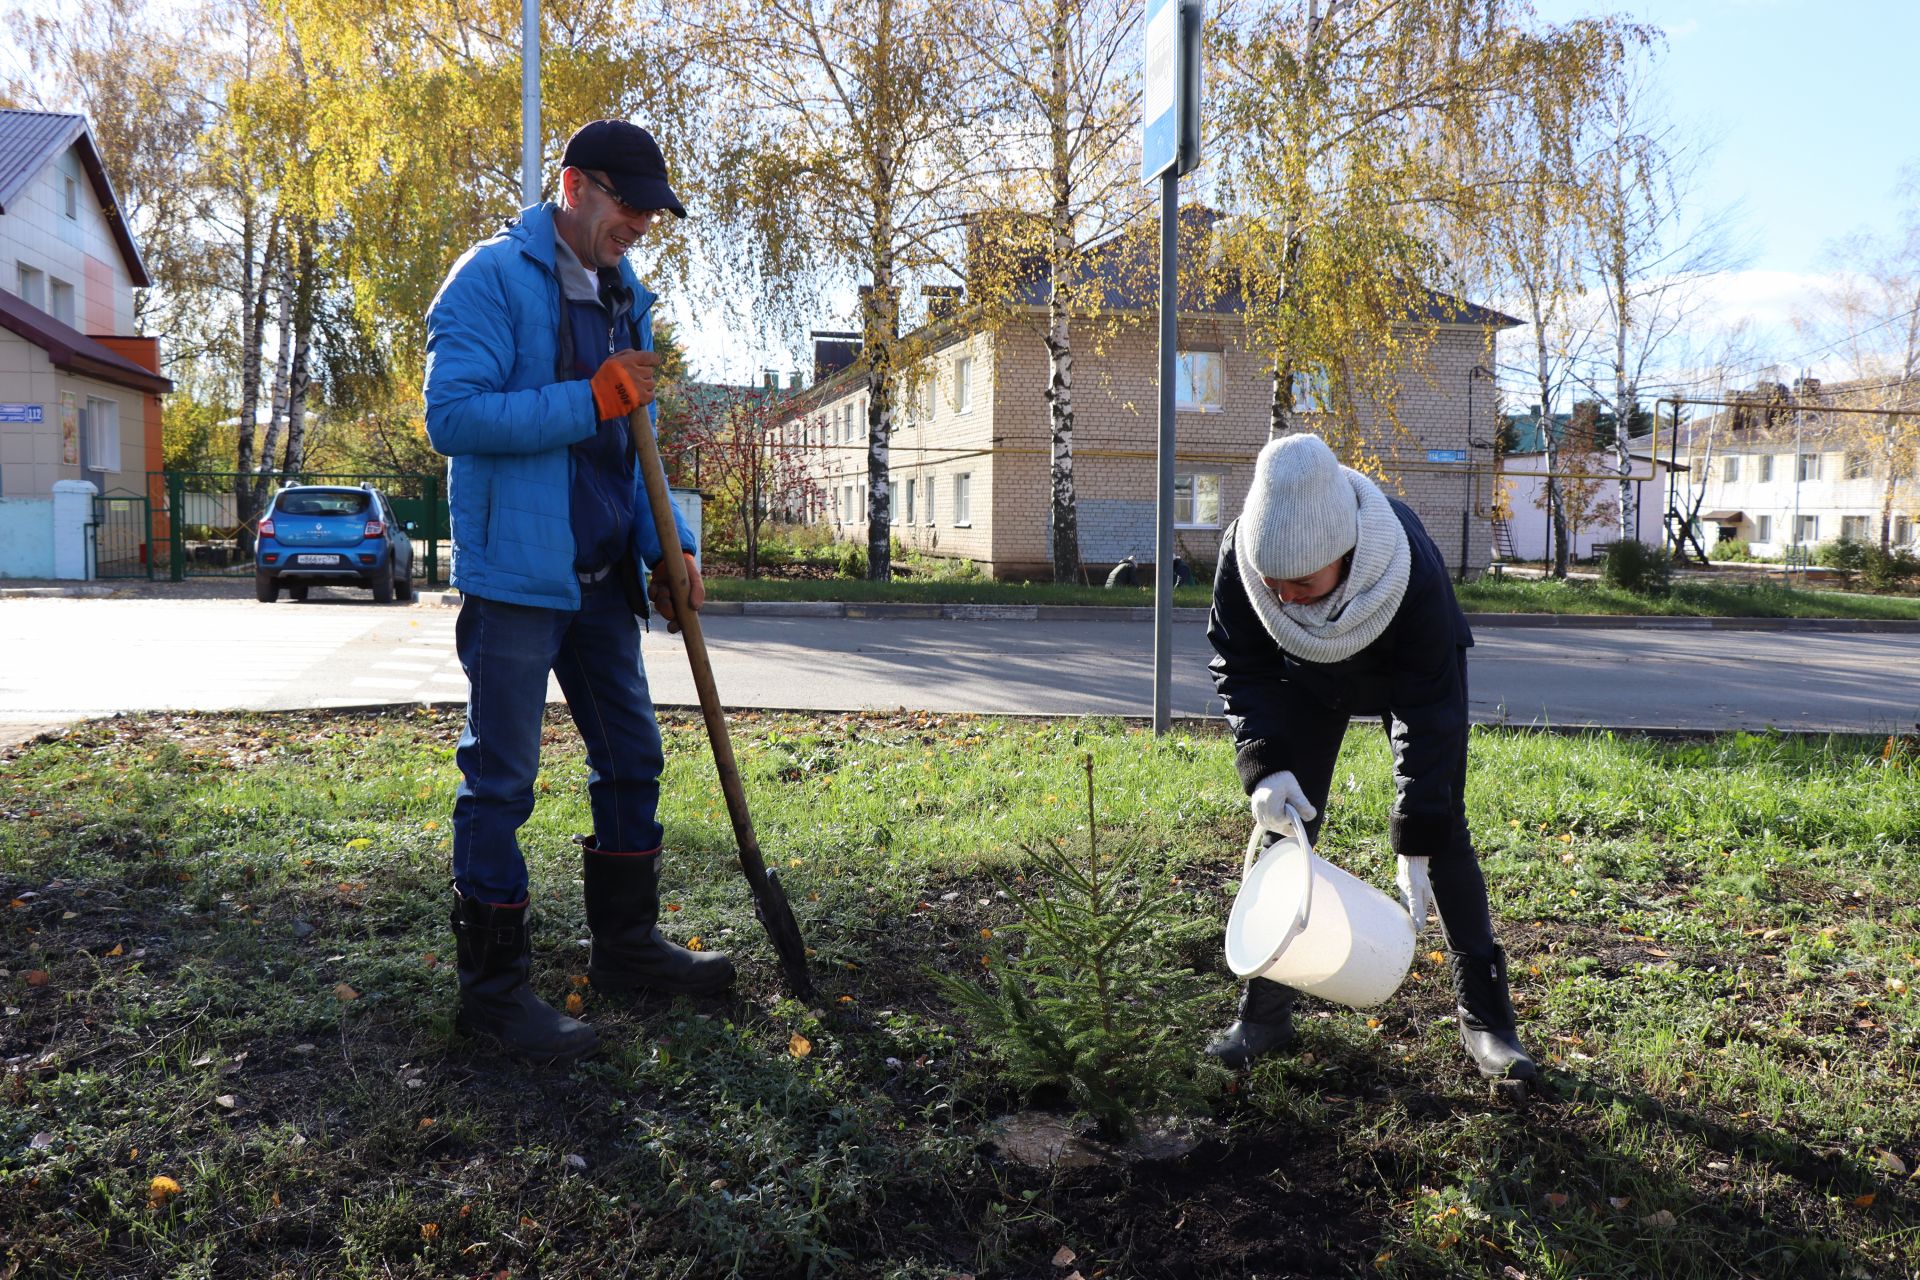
[426,203,693,608]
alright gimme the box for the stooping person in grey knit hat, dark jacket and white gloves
[1208,434,1534,1080]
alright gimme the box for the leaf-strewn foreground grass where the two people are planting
[0,712,1920,1280]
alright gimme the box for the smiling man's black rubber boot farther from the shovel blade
[453,889,599,1061]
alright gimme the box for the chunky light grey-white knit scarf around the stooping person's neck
[1235,466,1413,662]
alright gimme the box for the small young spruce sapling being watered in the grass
[933,756,1217,1136]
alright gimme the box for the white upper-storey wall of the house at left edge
[0,148,134,334]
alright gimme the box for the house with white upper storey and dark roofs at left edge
[0,111,173,578]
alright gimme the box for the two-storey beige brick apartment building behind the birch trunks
[780,226,1517,580]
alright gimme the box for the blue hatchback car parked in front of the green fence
[253,484,413,604]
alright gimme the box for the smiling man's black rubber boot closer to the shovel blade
[580,837,733,996]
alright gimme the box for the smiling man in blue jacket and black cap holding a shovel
[426,121,733,1061]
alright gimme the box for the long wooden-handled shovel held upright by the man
[628,405,814,1004]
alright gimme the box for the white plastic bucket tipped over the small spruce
[1227,806,1415,1009]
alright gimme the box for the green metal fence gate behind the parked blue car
[163,472,451,585]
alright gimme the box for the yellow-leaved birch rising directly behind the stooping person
[1208,0,1538,455]
